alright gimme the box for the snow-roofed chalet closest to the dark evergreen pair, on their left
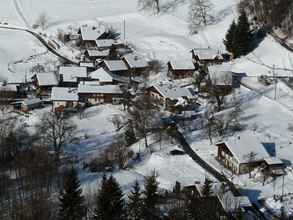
[191,48,224,65]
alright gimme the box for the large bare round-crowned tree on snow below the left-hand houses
[36,112,76,160]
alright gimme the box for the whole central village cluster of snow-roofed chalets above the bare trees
[0,25,232,111]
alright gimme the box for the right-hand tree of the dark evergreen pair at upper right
[234,11,252,57]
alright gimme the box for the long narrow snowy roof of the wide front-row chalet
[78,83,123,94]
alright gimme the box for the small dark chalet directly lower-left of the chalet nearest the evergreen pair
[167,60,196,79]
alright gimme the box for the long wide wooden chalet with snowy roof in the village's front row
[78,82,123,105]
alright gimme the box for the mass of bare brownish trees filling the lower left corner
[0,98,75,220]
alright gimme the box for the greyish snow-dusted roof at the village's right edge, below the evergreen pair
[208,63,233,86]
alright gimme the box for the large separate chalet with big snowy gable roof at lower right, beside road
[216,131,282,175]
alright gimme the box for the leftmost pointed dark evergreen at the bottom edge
[59,168,86,220]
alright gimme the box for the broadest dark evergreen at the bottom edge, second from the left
[94,175,125,220]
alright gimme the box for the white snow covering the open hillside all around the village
[0,0,293,218]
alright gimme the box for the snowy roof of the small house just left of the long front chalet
[51,87,78,101]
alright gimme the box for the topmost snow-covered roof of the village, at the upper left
[80,25,106,41]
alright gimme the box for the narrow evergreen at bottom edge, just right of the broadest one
[128,181,143,220]
